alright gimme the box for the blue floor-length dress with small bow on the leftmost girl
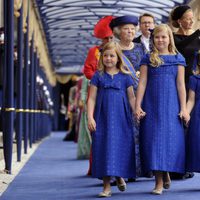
[91,72,135,178]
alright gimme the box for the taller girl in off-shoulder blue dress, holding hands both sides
[135,24,189,194]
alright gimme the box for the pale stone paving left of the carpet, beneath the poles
[0,142,41,196]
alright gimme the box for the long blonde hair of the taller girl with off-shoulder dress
[150,24,178,67]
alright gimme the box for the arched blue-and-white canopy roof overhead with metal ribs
[36,0,188,73]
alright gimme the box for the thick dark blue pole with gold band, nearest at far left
[3,0,15,173]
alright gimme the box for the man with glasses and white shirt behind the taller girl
[133,13,155,52]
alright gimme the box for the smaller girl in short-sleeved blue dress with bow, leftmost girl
[88,42,135,197]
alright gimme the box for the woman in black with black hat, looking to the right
[170,5,200,86]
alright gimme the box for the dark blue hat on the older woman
[110,15,138,29]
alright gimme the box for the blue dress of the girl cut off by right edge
[186,75,200,172]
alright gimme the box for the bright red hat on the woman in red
[94,16,114,39]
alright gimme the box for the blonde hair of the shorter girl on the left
[97,41,130,74]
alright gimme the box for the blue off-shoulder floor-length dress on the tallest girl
[140,54,185,173]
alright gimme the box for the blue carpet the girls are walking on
[0,132,200,200]
